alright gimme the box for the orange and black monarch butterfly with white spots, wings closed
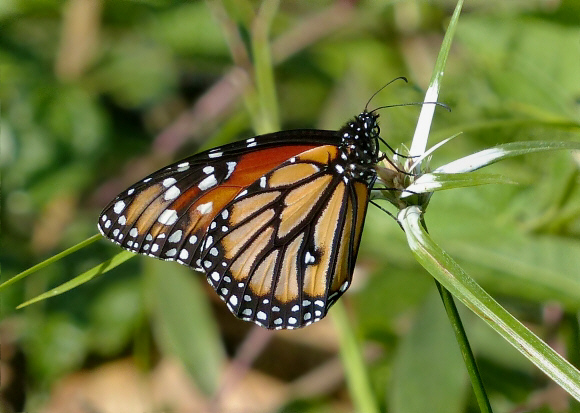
[98,110,384,329]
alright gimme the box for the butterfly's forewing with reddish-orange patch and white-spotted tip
[98,131,329,260]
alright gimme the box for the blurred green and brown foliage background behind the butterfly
[0,0,580,413]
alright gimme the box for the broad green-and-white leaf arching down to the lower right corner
[399,207,580,400]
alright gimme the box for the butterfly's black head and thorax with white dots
[340,111,380,183]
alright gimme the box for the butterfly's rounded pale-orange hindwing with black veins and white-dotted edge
[201,147,369,329]
